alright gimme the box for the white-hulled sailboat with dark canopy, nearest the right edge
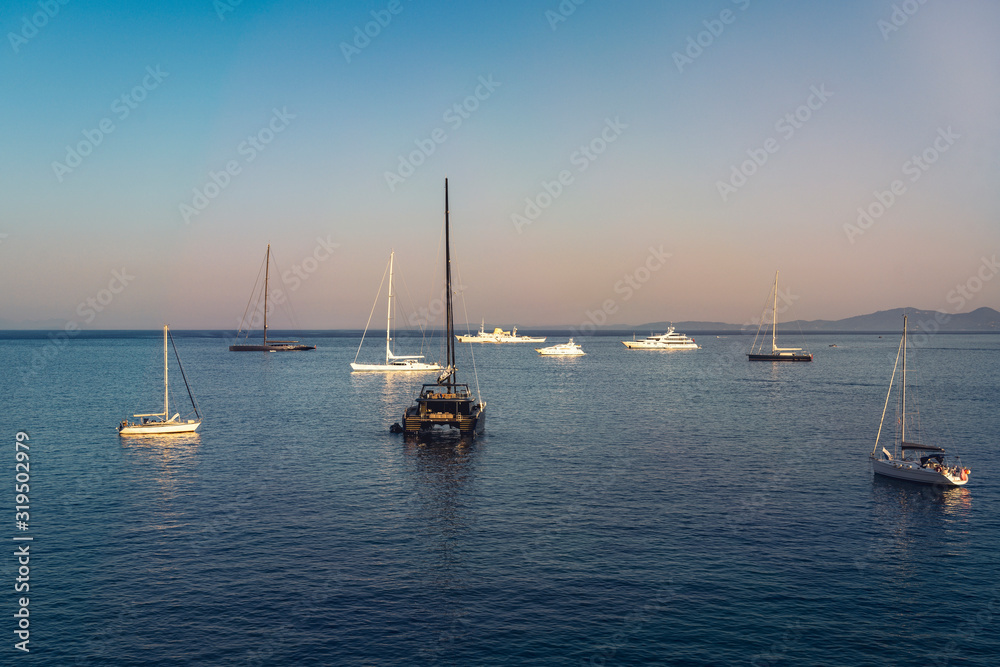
[870,315,969,486]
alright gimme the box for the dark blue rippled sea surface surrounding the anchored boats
[0,331,1000,667]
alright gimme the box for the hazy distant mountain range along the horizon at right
[636,308,1000,333]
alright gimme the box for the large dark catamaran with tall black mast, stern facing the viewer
[391,178,486,437]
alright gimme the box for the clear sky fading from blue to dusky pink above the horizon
[0,0,1000,331]
